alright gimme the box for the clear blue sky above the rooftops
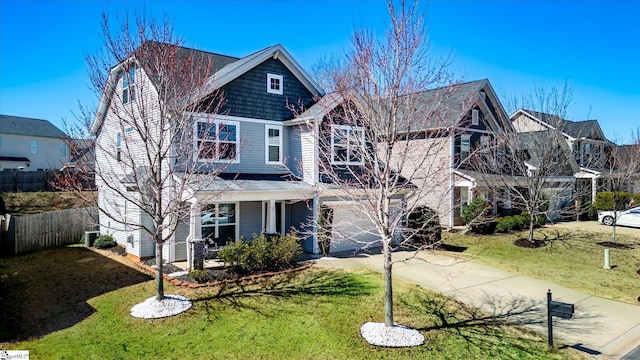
[0,0,640,142]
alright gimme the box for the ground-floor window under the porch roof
[200,203,238,246]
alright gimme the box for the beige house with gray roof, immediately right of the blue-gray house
[390,79,514,228]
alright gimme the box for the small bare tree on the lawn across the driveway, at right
[469,82,580,242]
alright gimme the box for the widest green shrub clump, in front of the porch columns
[218,233,302,274]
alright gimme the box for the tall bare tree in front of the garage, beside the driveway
[318,1,459,327]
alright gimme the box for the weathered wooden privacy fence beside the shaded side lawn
[0,207,98,256]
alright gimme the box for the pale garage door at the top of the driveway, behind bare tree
[331,205,380,253]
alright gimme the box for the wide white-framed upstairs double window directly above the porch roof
[195,120,239,162]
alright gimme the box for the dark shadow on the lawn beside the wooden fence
[0,247,152,341]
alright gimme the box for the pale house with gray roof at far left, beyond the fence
[0,115,69,171]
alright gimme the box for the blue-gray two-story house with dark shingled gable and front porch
[92,45,396,262]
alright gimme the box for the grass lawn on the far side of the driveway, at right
[444,226,640,304]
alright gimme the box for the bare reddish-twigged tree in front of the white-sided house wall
[69,11,228,300]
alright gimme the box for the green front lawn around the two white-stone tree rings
[0,247,581,359]
